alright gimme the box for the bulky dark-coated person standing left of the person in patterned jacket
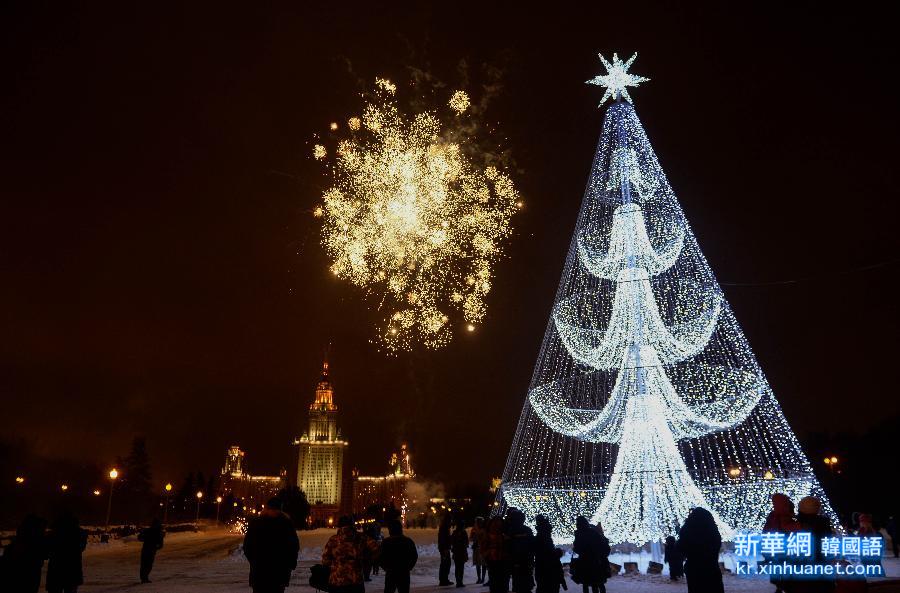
[244,498,300,593]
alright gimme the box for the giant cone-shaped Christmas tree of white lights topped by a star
[500,55,834,545]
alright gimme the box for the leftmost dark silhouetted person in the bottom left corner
[0,515,47,593]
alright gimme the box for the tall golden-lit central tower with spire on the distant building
[294,360,349,524]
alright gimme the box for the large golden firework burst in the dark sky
[314,79,521,352]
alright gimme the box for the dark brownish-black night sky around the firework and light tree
[0,2,900,483]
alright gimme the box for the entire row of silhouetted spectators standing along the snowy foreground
[0,494,884,593]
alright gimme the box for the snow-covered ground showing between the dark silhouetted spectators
[49,529,900,593]
